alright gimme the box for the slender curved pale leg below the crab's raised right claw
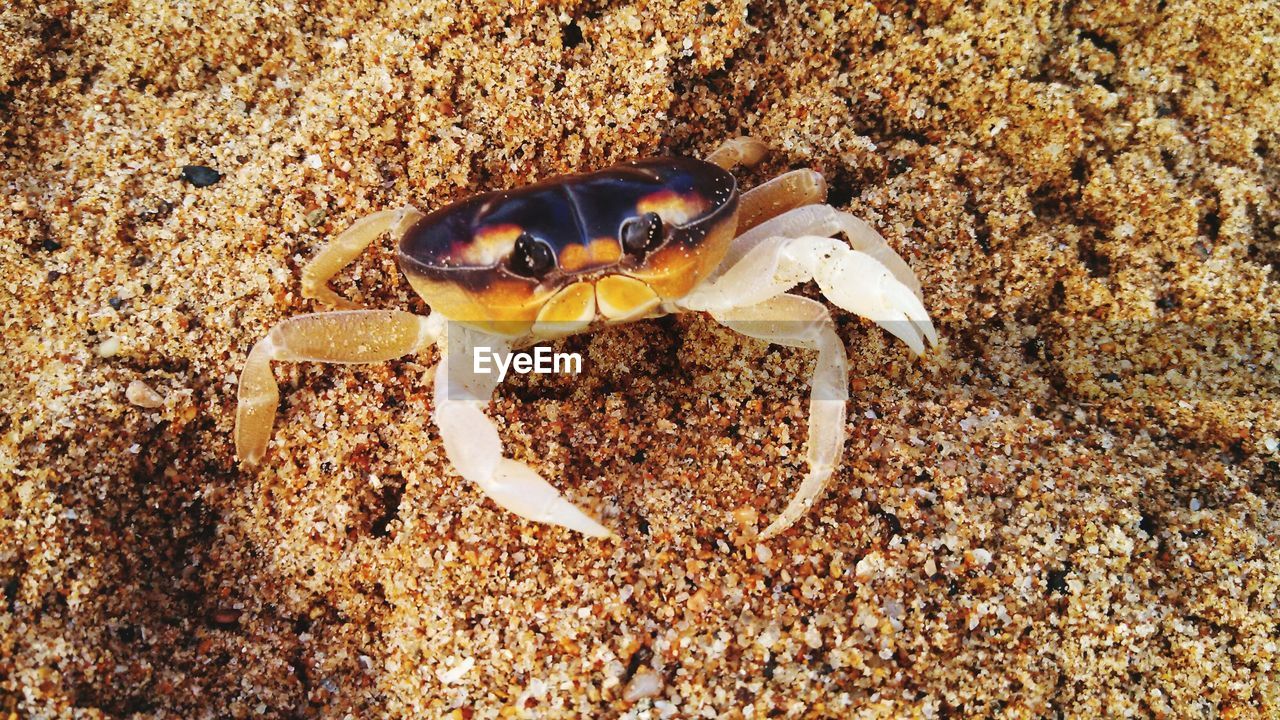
[712,295,849,539]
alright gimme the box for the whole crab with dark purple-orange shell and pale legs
[234,137,938,539]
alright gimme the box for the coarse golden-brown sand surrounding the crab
[0,0,1280,717]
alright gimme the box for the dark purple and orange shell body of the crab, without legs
[399,158,739,337]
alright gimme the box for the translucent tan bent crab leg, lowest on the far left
[236,310,443,465]
